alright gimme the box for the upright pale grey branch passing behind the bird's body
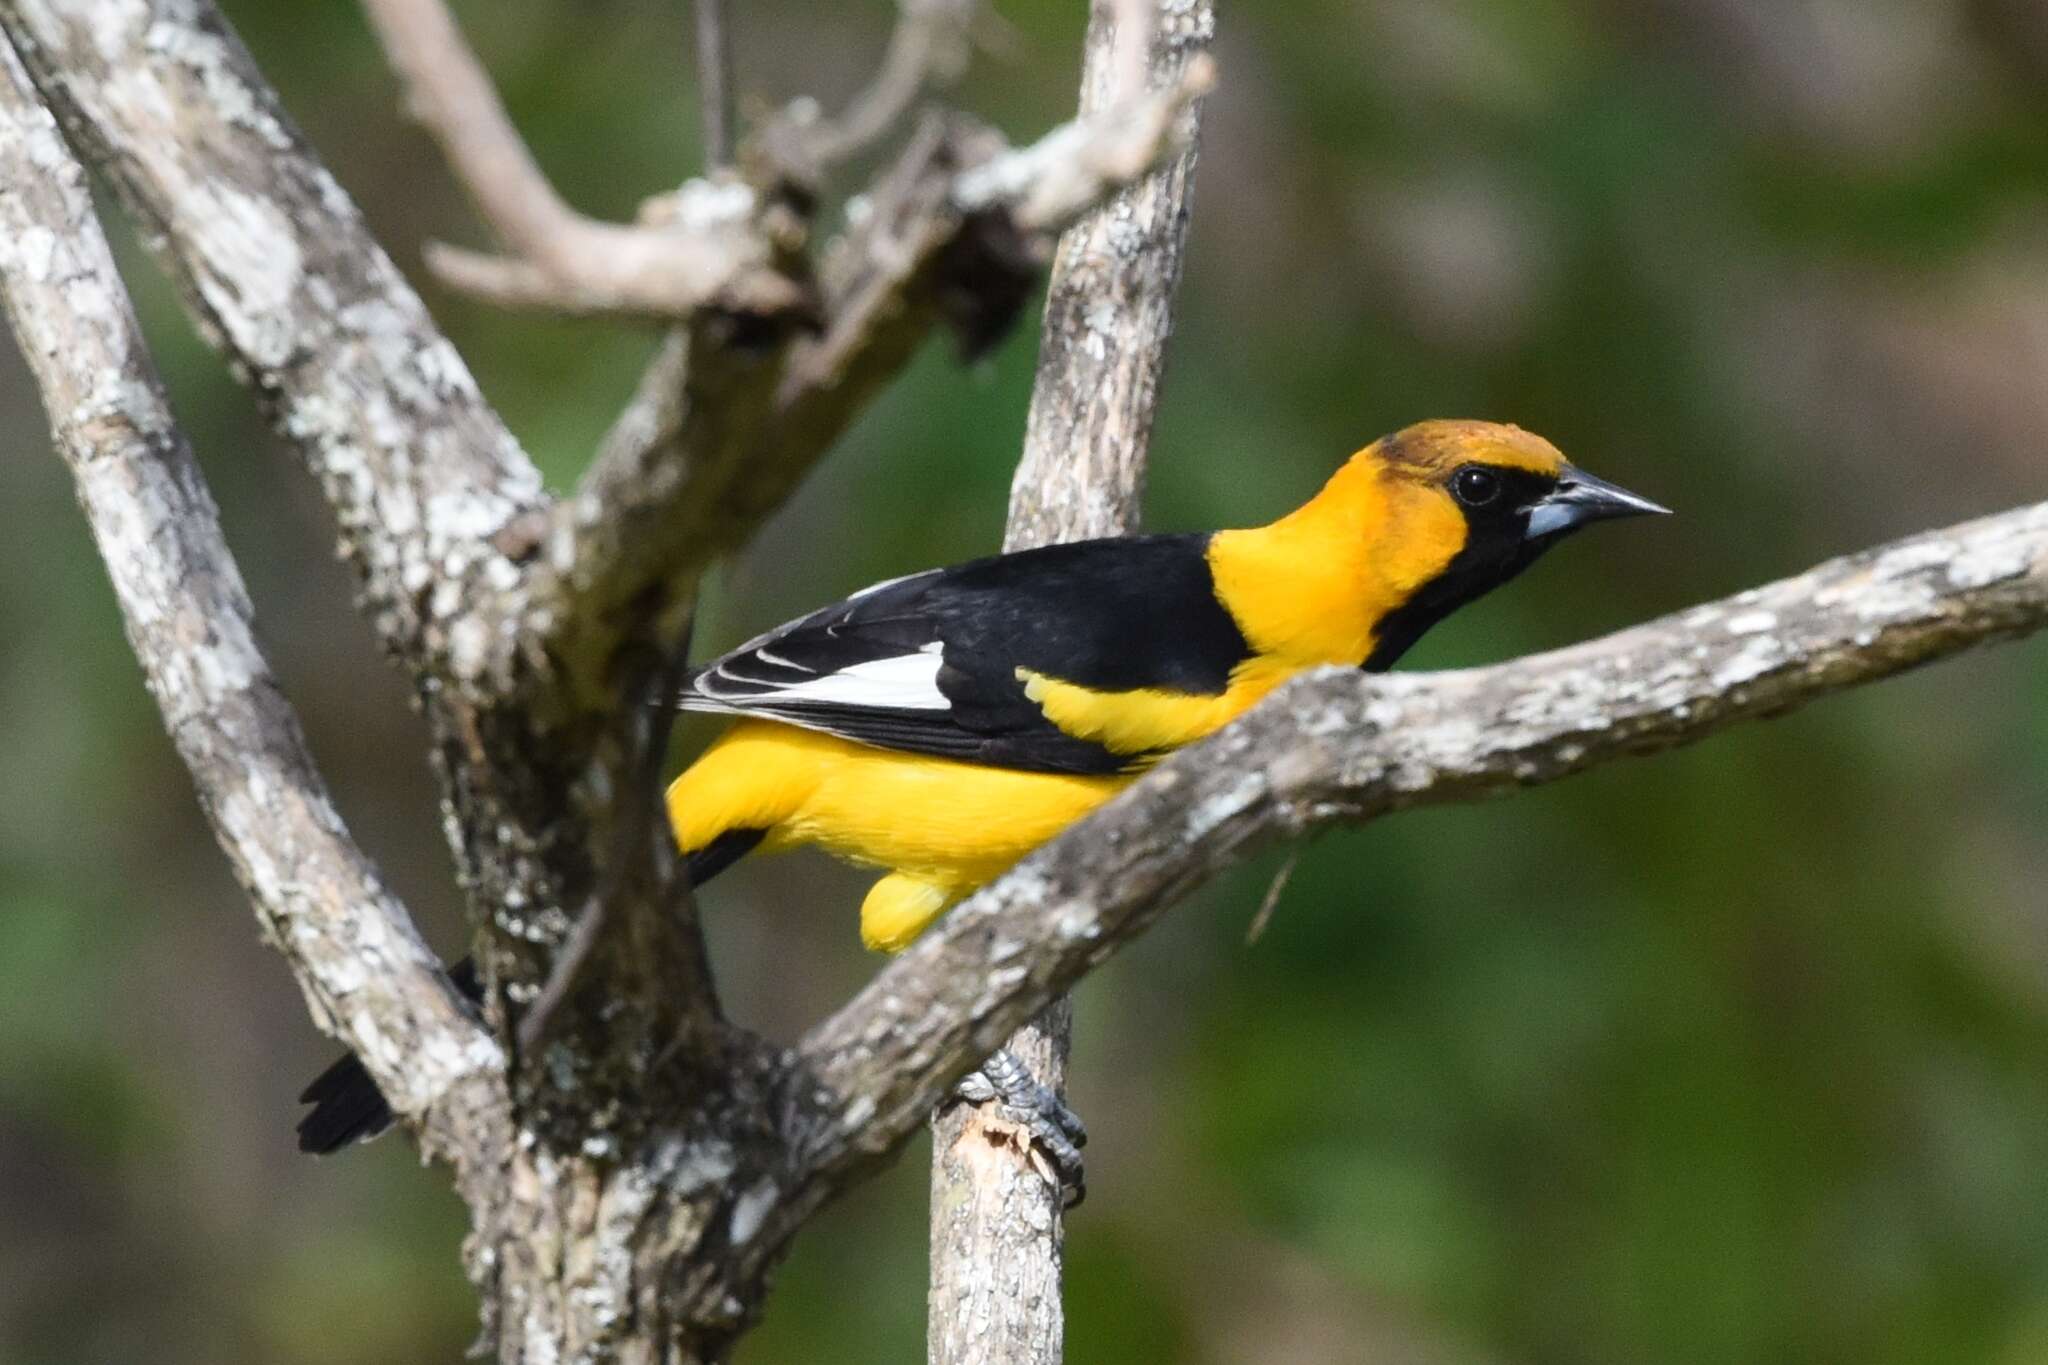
[926,0,1214,1365]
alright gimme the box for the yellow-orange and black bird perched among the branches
[299,420,1667,1179]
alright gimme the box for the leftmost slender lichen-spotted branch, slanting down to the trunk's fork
[0,41,504,1154]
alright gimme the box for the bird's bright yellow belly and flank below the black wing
[668,720,1130,950]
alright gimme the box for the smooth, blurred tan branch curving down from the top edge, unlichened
[362,0,805,317]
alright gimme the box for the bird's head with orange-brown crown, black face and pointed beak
[1348,422,1667,667]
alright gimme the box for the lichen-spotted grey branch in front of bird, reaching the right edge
[801,503,2048,1183]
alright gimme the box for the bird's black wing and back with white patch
[682,536,1251,774]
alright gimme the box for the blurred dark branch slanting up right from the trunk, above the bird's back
[552,74,1184,687]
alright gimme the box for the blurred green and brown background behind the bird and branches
[0,0,2048,1365]
